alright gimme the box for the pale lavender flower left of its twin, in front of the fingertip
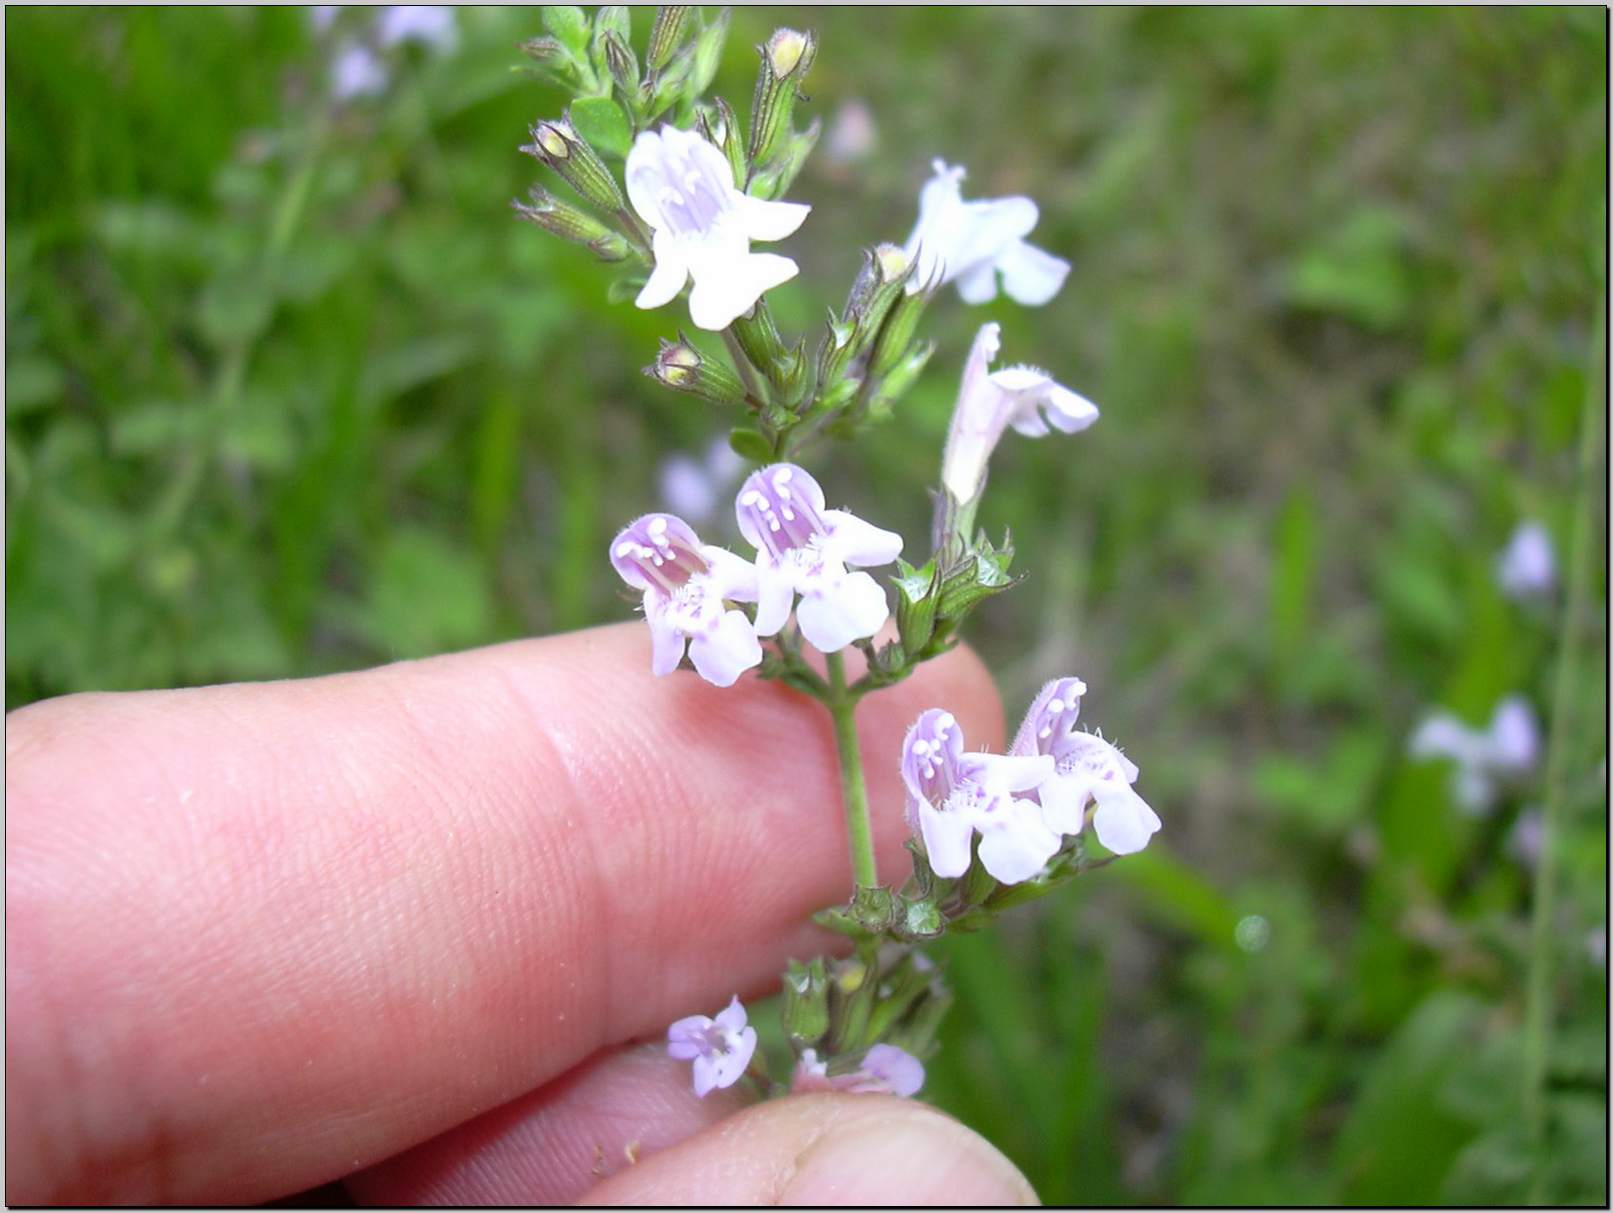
[902,708,1060,884]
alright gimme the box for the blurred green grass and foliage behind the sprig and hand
[5,8,1607,1203]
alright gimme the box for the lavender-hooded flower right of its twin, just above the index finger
[734,463,902,653]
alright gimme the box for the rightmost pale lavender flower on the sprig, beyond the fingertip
[1008,677,1161,855]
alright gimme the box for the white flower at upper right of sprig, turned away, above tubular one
[907,160,1069,306]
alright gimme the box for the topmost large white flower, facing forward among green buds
[627,126,811,331]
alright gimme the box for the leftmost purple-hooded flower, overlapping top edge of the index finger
[610,515,761,687]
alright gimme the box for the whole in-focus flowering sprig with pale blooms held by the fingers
[516,5,1160,1116]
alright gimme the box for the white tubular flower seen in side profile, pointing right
[940,324,1098,503]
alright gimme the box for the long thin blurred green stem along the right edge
[1523,301,1607,1203]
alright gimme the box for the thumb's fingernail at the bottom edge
[779,1097,1040,1205]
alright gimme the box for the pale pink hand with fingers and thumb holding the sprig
[5,624,1034,1205]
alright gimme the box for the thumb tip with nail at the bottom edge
[582,1094,1039,1207]
